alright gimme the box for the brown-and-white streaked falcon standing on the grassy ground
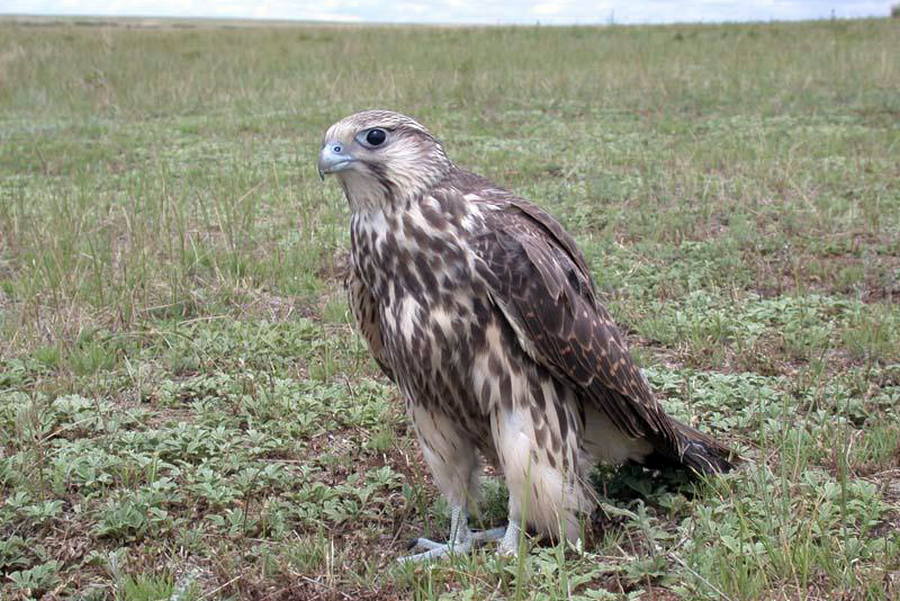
[318,110,731,561]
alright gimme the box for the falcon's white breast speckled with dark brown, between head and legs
[351,205,495,445]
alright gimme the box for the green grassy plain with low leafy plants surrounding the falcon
[0,14,900,601]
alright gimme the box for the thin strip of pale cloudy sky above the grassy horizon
[0,0,898,25]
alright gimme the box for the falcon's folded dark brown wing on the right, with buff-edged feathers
[472,194,727,471]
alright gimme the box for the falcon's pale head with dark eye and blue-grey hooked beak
[318,110,451,209]
